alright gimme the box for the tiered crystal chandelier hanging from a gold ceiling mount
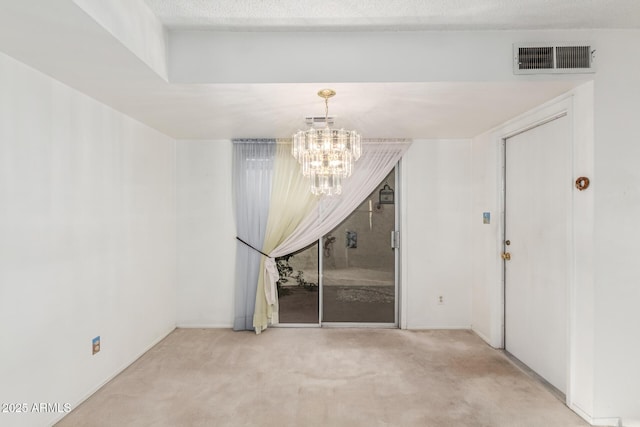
[291,89,362,196]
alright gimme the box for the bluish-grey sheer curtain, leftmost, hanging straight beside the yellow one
[233,140,276,330]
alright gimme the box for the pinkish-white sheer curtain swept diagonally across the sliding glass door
[254,140,411,332]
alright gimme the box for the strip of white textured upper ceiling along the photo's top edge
[145,0,640,31]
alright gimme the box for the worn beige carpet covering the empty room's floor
[58,328,587,427]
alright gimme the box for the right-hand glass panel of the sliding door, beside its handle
[321,169,396,324]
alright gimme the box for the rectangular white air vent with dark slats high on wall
[513,43,596,74]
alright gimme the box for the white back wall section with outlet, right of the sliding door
[401,139,471,329]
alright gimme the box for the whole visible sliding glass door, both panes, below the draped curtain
[277,168,398,327]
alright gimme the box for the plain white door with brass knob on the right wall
[504,116,572,394]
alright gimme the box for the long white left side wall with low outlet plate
[0,54,176,426]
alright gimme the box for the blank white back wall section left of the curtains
[177,140,236,328]
